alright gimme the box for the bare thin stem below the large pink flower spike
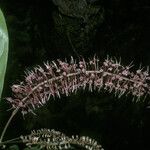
[0,107,20,143]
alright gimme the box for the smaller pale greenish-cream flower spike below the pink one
[20,129,104,150]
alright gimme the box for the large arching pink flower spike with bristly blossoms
[7,57,150,115]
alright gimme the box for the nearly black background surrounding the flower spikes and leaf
[0,0,150,150]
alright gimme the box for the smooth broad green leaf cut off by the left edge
[0,10,8,98]
